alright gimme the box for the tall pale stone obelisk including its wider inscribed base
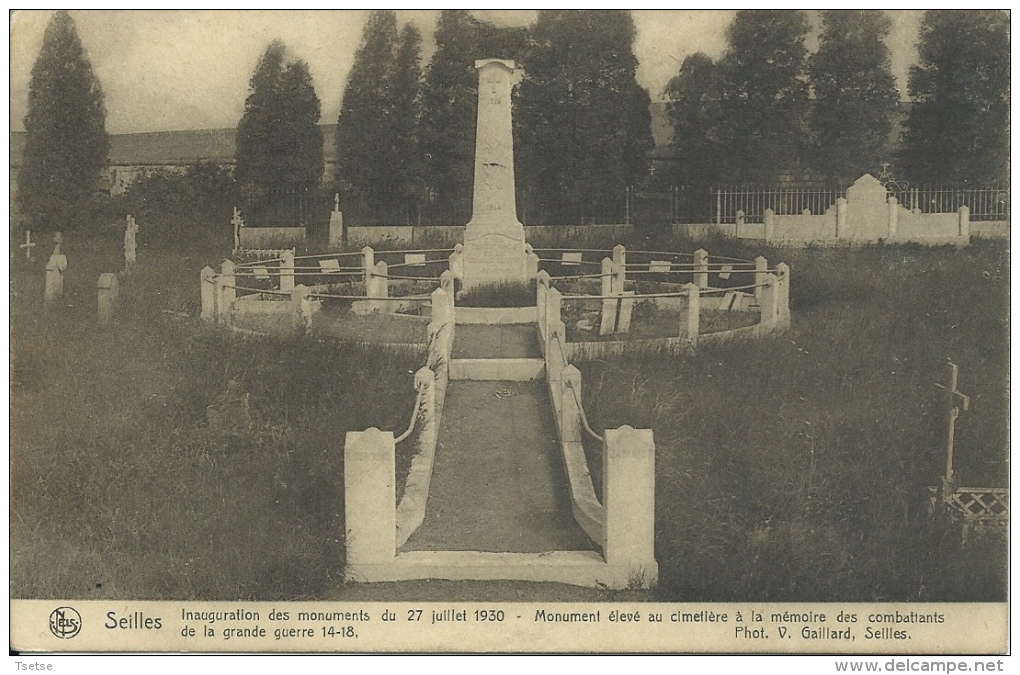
[464,58,527,288]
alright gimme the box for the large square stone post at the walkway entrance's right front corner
[602,426,659,588]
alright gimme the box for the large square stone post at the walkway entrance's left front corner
[344,427,397,575]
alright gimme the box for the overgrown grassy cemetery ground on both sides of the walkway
[10,222,1009,602]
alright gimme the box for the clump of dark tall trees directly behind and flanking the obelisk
[337,10,652,222]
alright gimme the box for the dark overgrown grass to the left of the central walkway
[10,237,419,600]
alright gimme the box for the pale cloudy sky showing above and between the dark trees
[9,10,922,134]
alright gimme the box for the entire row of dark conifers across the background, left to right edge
[17,10,1010,228]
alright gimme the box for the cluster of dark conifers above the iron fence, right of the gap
[667,10,1010,191]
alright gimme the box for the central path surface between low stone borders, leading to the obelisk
[403,325,594,553]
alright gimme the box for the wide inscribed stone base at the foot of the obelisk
[464,222,528,289]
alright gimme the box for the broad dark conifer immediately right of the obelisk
[515,10,653,222]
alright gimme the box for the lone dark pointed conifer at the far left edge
[17,11,110,230]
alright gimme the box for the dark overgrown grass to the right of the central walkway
[580,237,1009,602]
